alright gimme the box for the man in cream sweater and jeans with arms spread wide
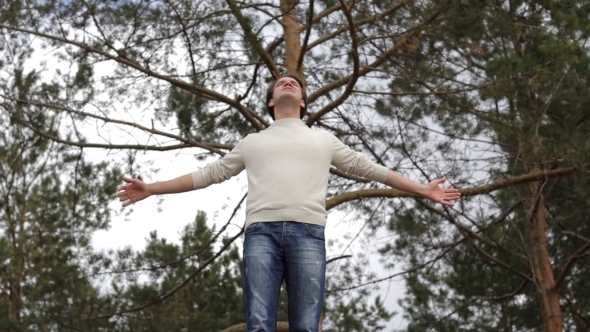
[118,75,460,332]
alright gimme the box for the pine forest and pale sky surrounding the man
[0,0,590,332]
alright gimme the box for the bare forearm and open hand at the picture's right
[385,170,461,206]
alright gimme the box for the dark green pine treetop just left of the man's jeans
[98,211,243,331]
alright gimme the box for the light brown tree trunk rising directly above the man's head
[281,0,305,82]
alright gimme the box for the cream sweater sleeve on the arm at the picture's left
[191,142,245,189]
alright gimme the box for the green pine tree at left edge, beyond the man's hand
[0,69,120,331]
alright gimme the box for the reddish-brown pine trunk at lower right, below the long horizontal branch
[527,175,563,332]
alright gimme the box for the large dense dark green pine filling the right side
[376,1,590,331]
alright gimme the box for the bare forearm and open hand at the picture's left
[117,174,194,207]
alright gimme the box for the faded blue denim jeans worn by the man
[242,221,326,332]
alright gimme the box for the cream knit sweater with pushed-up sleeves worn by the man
[191,118,388,227]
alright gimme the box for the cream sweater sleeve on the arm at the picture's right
[330,135,389,183]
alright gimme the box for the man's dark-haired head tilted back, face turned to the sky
[266,74,307,120]
